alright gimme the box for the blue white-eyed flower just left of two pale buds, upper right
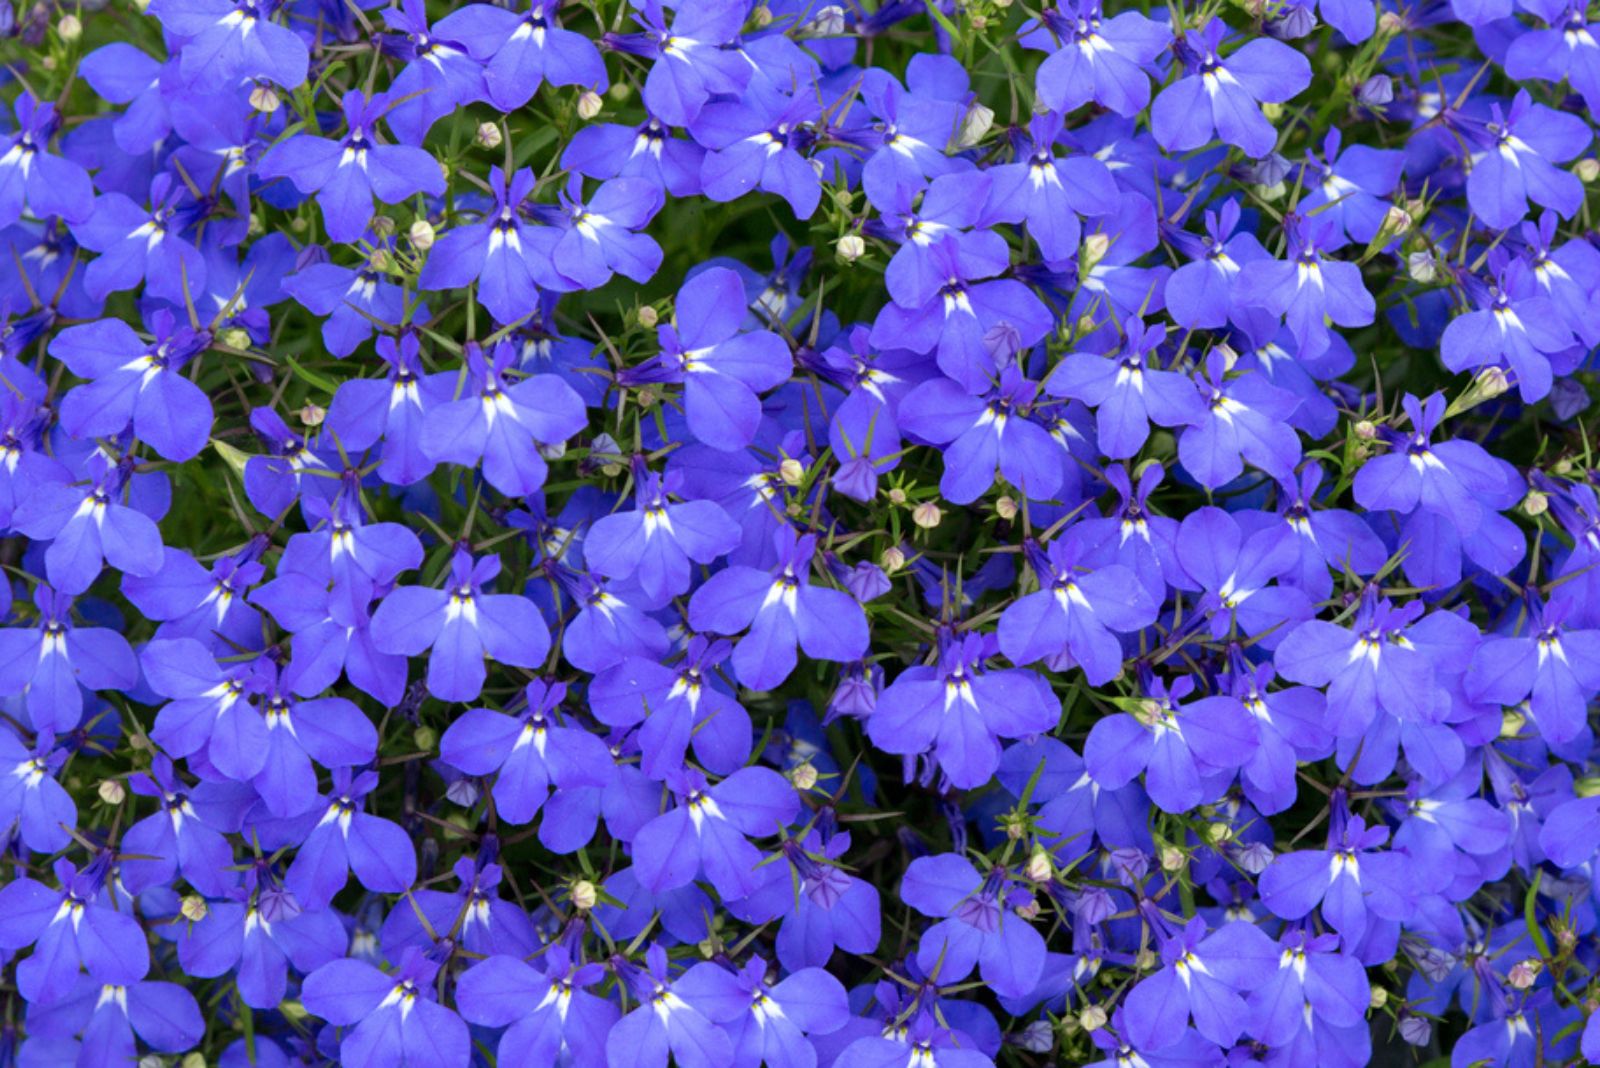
[1234,214,1378,360]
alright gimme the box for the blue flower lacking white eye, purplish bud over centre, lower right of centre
[901,854,1045,998]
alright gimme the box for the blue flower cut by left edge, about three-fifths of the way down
[0,582,139,734]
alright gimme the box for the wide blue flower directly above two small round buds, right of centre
[898,365,1062,504]
